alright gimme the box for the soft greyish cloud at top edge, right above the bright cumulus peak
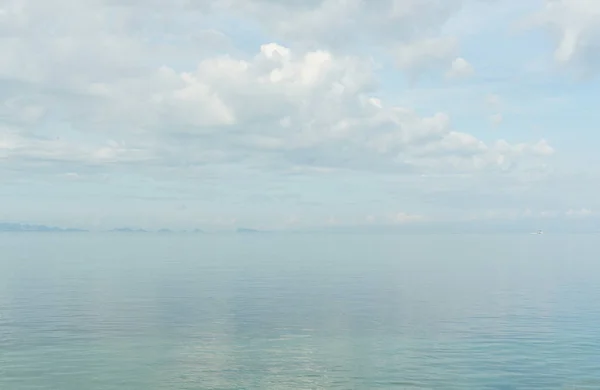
[220,0,482,78]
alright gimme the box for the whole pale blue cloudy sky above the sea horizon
[0,0,600,229]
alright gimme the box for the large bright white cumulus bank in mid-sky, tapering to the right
[4,34,551,171]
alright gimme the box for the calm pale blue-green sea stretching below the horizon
[0,234,600,390]
